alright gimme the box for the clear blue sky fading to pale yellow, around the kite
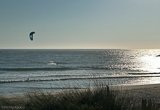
[0,0,160,49]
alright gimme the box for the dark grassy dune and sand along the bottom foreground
[0,84,160,110]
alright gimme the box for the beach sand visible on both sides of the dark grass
[0,84,160,108]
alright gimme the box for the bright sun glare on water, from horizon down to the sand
[128,49,160,85]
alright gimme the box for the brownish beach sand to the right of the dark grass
[111,84,160,109]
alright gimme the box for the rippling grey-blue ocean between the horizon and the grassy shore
[0,49,160,95]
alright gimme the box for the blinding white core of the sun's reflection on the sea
[134,51,160,84]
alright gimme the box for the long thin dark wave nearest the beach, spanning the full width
[0,75,160,84]
